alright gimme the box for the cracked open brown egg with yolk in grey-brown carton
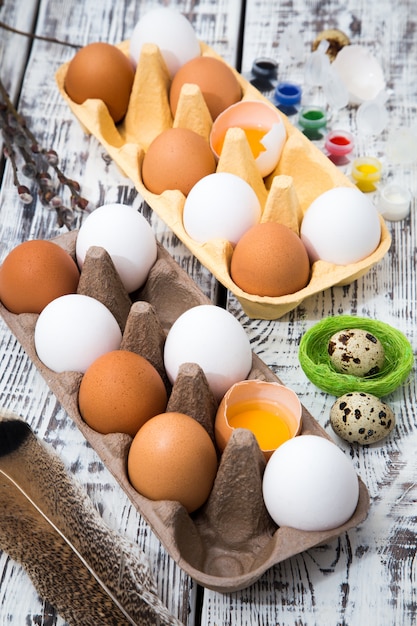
[214,380,302,459]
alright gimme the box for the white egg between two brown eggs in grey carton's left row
[34,294,122,373]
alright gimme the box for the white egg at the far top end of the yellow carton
[130,7,201,78]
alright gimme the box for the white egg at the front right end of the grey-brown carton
[262,435,359,531]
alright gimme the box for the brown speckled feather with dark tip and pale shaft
[0,412,181,626]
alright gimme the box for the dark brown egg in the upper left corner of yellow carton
[64,42,135,123]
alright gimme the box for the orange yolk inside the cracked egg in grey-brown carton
[227,400,293,450]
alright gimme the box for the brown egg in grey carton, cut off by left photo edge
[0,239,80,313]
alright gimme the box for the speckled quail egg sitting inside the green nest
[327,328,385,377]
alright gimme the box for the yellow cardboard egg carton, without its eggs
[56,41,391,319]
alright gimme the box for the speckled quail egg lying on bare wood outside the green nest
[330,391,395,444]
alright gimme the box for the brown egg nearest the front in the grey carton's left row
[128,412,217,513]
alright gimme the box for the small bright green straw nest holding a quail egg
[298,315,414,398]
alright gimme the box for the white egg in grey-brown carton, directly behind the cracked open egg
[164,304,252,400]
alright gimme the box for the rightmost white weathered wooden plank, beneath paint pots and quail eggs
[202,0,417,626]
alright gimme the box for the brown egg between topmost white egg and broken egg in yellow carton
[169,56,242,120]
